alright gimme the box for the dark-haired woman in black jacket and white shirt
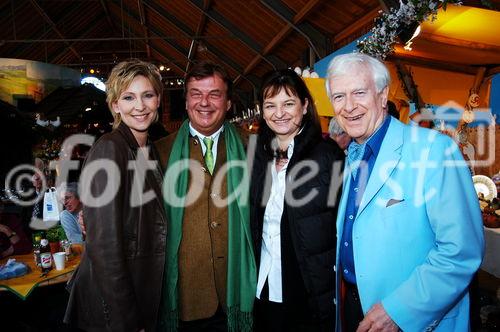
[250,69,344,332]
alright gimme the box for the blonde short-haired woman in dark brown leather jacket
[65,60,166,331]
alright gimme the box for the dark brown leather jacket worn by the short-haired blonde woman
[65,123,166,331]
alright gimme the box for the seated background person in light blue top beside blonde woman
[61,182,83,243]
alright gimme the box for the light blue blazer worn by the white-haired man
[336,119,484,332]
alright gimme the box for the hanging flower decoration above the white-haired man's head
[357,0,461,60]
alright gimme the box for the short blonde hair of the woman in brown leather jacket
[106,59,163,129]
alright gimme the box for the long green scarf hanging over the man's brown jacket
[159,120,257,332]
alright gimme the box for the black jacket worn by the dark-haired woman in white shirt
[250,124,344,321]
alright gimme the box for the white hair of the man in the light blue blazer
[325,53,391,98]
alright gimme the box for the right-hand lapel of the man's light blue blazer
[357,119,405,216]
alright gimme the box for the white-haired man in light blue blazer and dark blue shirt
[326,53,484,332]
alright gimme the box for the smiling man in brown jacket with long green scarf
[156,62,256,331]
